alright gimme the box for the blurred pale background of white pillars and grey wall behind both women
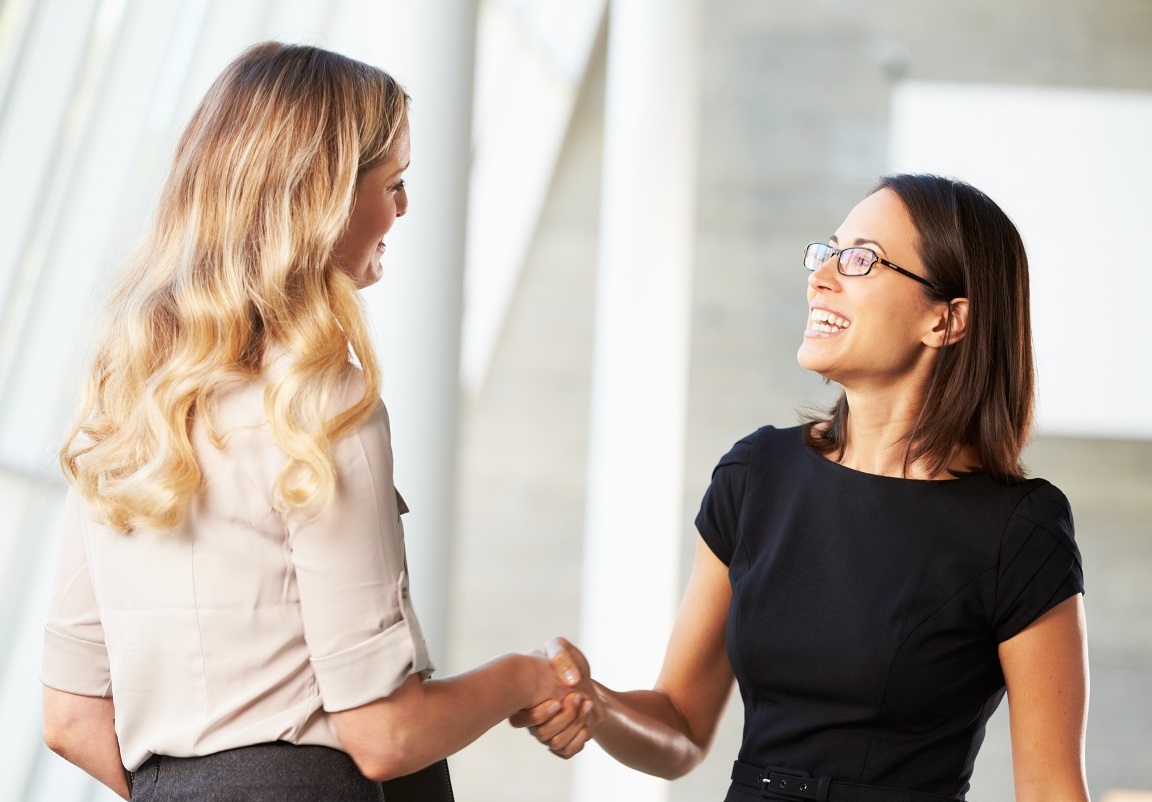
[0,0,1152,802]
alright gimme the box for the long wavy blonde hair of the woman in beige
[60,43,409,534]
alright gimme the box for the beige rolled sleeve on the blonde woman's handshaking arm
[289,404,432,712]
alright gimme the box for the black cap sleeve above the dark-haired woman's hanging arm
[993,483,1084,642]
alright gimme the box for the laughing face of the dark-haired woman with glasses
[796,189,947,392]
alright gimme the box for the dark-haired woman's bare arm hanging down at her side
[1000,595,1089,802]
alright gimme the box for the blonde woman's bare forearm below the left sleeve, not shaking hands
[44,686,128,800]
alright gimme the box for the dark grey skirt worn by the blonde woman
[131,741,386,802]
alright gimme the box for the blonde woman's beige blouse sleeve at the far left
[40,489,112,696]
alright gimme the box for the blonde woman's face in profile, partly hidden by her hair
[332,122,410,289]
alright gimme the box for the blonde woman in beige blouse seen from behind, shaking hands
[41,43,566,801]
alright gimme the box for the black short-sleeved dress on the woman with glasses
[696,426,1084,800]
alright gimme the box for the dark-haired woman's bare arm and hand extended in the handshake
[513,540,734,779]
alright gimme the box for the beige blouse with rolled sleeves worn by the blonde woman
[41,370,432,771]
